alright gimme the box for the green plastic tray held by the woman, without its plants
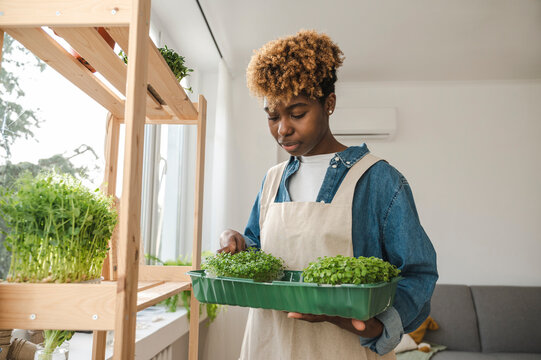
[188,270,402,320]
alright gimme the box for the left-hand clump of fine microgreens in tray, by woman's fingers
[201,248,284,282]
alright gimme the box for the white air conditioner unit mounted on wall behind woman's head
[329,107,397,140]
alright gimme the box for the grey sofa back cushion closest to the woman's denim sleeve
[423,284,481,352]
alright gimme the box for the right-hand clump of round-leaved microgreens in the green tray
[302,255,400,285]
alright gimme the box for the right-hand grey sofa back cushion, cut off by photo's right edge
[471,286,541,353]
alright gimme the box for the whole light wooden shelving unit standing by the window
[0,0,206,360]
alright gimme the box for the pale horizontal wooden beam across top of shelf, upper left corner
[0,0,131,28]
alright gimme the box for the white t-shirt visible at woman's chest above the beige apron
[288,153,335,202]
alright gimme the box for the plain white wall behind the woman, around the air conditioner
[204,79,541,359]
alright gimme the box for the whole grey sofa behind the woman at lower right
[424,284,541,360]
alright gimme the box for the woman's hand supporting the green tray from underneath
[287,312,383,338]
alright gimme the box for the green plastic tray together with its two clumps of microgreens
[188,249,402,320]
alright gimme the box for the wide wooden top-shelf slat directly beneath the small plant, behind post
[106,27,197,120]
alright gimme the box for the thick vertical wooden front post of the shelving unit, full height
[114,0,150,360]
